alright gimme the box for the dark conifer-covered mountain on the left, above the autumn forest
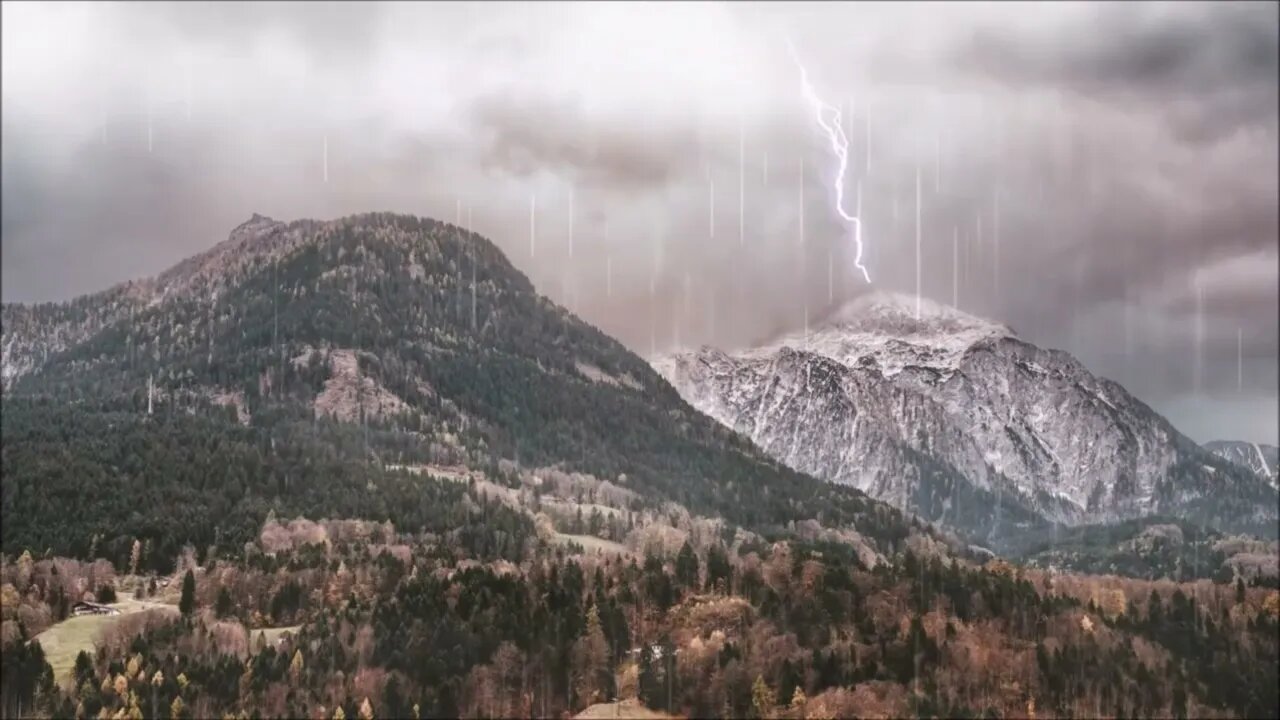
[0,214,936,561]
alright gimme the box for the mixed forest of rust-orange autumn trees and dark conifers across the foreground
[3,497,1280,717]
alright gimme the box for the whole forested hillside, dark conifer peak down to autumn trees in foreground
[0,214,1280,720]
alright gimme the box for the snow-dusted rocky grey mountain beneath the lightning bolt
[653,286,1276,542]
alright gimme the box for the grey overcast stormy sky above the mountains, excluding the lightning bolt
[3,3,1280,443]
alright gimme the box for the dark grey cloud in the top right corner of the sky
[956,3,1280,142]
